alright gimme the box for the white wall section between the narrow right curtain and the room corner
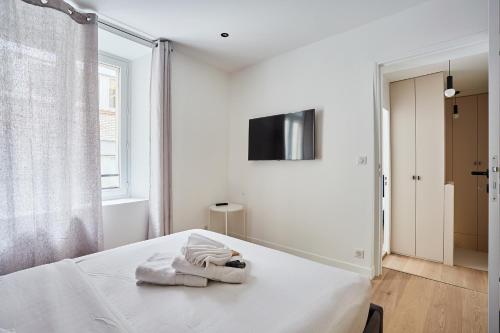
[172,51,229,232]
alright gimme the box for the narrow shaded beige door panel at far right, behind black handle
[477,94,488,252]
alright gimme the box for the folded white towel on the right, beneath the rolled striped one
[172,256,246,283]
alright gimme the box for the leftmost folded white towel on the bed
[135,253,207,287]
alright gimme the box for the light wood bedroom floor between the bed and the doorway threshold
[371,268,488,333]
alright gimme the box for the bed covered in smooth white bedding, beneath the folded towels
[0,230,370,333]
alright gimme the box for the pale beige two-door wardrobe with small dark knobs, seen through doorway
[390,73,445,262]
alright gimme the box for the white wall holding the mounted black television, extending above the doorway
[228,0,488,274]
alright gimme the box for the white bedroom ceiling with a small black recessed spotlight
[73,0,426,71]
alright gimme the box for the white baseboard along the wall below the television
[229,233,373,279]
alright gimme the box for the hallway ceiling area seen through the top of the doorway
[384,53,488,96]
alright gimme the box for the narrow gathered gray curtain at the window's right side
[148,41,172,238]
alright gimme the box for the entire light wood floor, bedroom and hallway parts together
[371,254,488,333]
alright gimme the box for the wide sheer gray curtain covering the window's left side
[0,0,102,274]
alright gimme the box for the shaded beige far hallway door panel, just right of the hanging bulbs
[453,96,478,250]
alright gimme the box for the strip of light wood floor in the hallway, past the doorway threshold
[382,254,488,293]
